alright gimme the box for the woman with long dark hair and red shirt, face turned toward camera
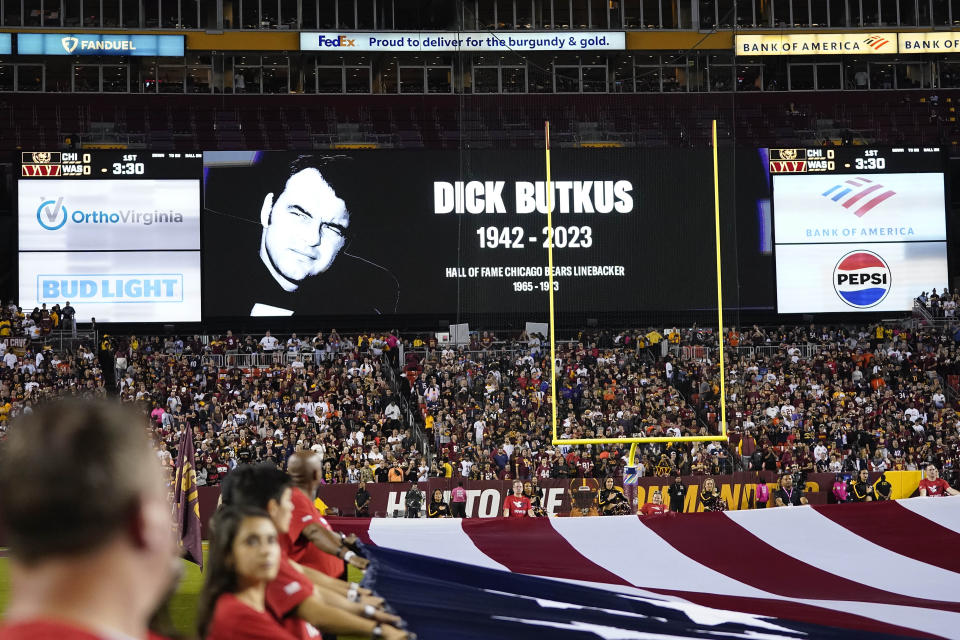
[197,507,296,640]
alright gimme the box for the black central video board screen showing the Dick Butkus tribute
[203,149,736,317]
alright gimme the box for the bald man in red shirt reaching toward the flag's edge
[287,451,368,578]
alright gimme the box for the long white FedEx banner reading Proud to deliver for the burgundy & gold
[300,31,626,53]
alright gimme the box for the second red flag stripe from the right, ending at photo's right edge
[644,513,960,612]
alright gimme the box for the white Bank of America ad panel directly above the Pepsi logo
[773,173,947,245]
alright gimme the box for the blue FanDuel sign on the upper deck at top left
[17,33,184,57]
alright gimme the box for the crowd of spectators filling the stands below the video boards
[0,294,960,492]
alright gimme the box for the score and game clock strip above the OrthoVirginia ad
[20,150,203,180]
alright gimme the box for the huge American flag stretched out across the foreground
[331,497,960,639]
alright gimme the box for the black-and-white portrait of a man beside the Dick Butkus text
[206,154,399,316]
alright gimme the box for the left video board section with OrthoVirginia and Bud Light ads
[17,151,202,322]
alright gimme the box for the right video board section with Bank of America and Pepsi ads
[769,147,948,313]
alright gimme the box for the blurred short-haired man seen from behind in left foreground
[0,400,179,640]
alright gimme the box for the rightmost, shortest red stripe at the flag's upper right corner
[814,502,960,573]
